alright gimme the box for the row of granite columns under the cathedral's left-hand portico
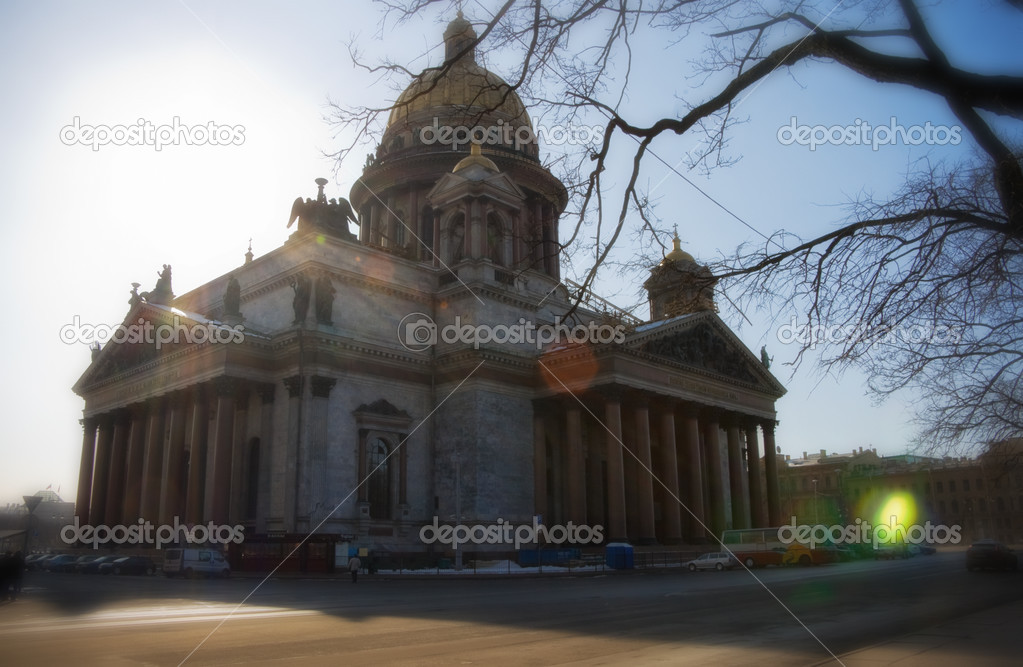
[75,377,274,526]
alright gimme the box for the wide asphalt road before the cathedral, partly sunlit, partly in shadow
[0,552,1023,665]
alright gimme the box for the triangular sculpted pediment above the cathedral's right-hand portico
[624,311,785,396]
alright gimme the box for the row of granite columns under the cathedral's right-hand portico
[533,391,781,544]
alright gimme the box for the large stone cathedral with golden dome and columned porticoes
[74,15,785,570]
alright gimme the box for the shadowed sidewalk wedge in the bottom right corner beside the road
[815,601,1023,667]
